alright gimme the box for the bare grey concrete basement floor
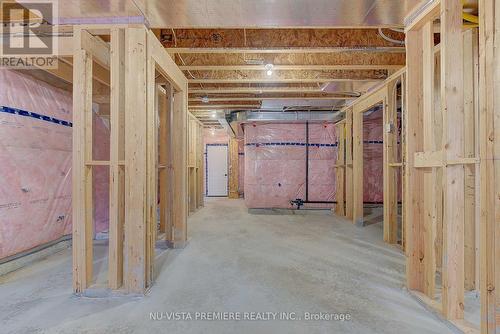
[0,199,456,334]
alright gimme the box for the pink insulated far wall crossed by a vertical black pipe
[244,123,337,208]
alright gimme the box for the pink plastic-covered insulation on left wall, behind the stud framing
[0,70,108,258]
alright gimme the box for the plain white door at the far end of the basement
[207,144,228,196]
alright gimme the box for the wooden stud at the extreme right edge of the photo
[479,0,500,334]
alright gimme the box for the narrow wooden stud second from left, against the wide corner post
[108,28,125,289]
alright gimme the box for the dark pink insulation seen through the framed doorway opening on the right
[363,109,384,203]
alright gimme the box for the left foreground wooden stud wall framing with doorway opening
[71,26,191,293]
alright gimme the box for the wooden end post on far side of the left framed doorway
[172,88,188,248]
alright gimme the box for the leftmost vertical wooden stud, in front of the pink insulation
[72,29,93,293]
